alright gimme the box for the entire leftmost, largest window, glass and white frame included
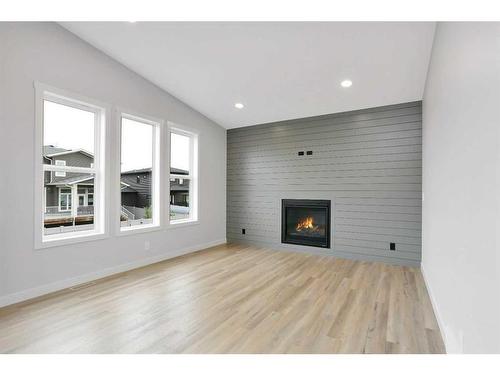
[35,86,105,247]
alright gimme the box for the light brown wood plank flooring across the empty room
[0,244,444,353]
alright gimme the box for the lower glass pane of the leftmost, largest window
[43,172,94,236]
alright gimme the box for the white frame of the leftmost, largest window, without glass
[34,82,109,249]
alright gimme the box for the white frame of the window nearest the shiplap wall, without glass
[166,122,200,228]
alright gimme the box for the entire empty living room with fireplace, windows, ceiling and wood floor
[0,0,500,372]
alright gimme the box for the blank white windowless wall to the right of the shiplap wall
[422,23,500,353]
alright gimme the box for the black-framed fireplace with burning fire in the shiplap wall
[281,199,331,248]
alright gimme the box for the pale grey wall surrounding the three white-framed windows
[0,23,226,305]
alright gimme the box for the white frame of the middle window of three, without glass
[113,108,160,235]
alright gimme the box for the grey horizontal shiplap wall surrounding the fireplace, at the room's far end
[227,102,422,265]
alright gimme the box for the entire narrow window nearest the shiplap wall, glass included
[169,128,198,224]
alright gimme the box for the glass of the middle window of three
[120,118,153,227]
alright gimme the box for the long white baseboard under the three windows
[0,238,226,307]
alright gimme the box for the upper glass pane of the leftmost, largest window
[43,100,95,169]
